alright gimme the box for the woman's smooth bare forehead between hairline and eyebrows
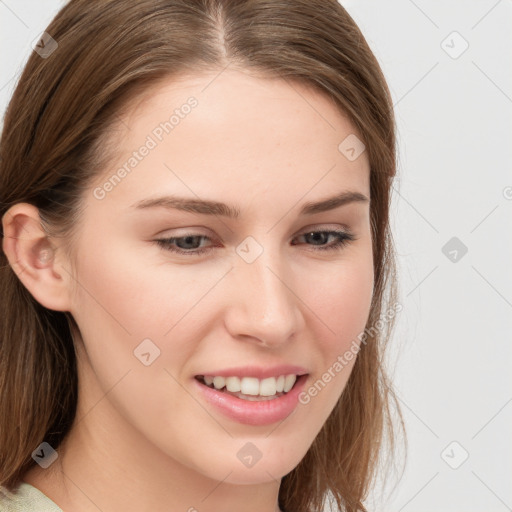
[88,69,369,210]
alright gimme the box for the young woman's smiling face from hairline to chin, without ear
[66,70,374,483]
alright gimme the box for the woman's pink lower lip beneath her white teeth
[192,375,308,425]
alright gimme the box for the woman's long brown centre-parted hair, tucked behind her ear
[0,0,405,512]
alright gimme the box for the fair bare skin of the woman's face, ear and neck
[2,70,374,512]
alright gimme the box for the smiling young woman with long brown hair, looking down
[0,0,403,512]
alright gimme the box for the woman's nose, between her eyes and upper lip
[225,243,303,347]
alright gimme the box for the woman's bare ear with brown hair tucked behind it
[2,203,72,311]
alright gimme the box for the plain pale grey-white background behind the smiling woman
[0,0,512,512]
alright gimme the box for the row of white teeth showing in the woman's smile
[200,374,297,396]
